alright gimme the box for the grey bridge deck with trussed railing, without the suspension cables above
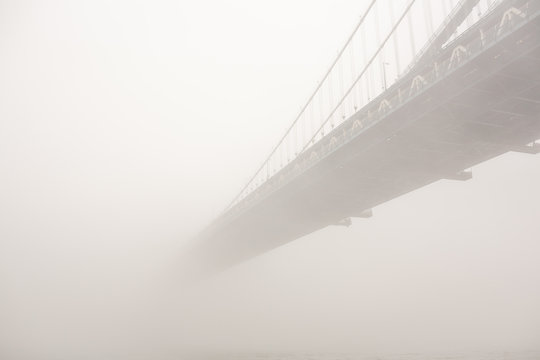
[192,1,540,266]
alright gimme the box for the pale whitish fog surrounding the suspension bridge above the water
[0,0,540,360]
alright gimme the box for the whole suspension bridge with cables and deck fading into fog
[187,0,540,267]
